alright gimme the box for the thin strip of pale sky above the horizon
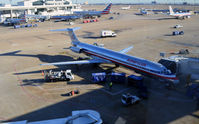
[0,0,199,3]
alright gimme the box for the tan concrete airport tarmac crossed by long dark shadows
[0,5,199,124]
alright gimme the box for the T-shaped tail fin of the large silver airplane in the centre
[50,27,80,45]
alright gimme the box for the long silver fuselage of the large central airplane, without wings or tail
[73,42,177,80]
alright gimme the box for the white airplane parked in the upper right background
[169,6,191,19]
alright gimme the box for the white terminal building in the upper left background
[0,0,81,22]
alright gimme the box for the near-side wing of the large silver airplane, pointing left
[40,59,110,65]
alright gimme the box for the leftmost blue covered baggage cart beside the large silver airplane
[92,72,106,83]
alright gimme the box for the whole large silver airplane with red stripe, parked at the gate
[41,27,179,83]
